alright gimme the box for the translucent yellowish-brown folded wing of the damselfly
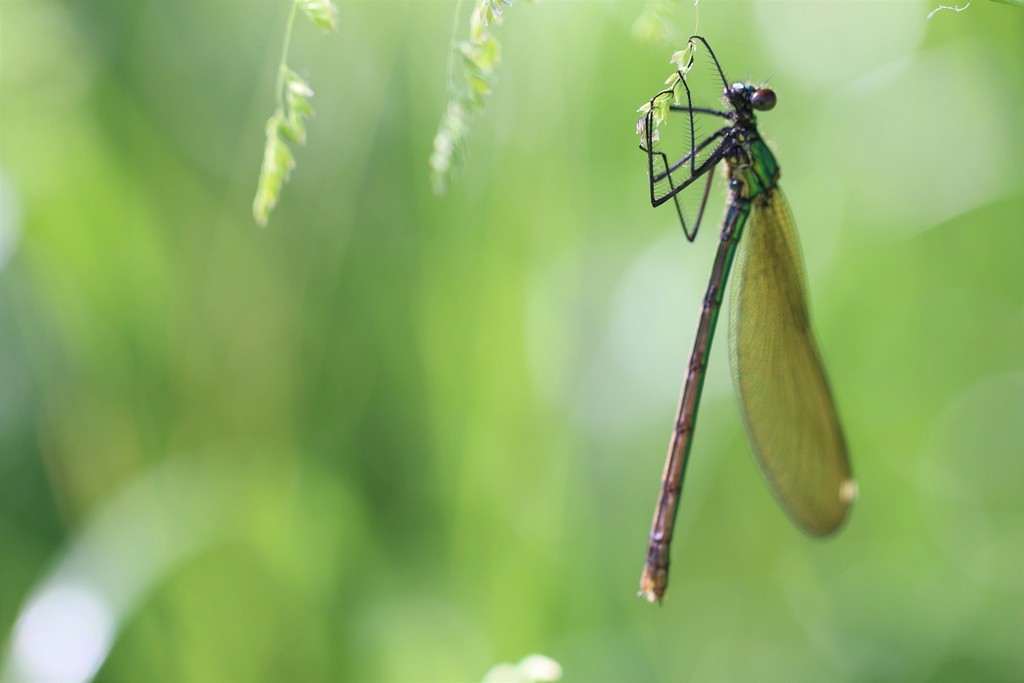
[730,188,855,536]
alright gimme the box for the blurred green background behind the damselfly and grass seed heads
[0,0,1024,683]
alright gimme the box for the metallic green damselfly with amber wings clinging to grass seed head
[638,36,856,602]
